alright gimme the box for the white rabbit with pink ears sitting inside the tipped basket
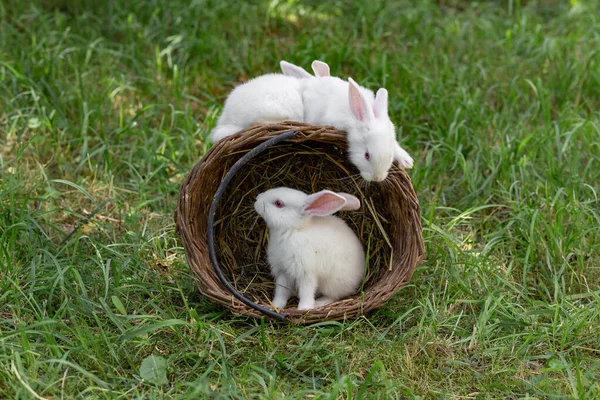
[254,187,365,310]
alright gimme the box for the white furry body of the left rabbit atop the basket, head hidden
[210,74,304,143]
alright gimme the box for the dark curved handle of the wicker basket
[206,131,297,321]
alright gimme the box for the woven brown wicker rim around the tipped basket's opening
[175,122,425,323]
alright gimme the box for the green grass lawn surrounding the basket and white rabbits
[0,0,600,399]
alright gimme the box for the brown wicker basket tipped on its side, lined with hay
[175,122,425,323]
